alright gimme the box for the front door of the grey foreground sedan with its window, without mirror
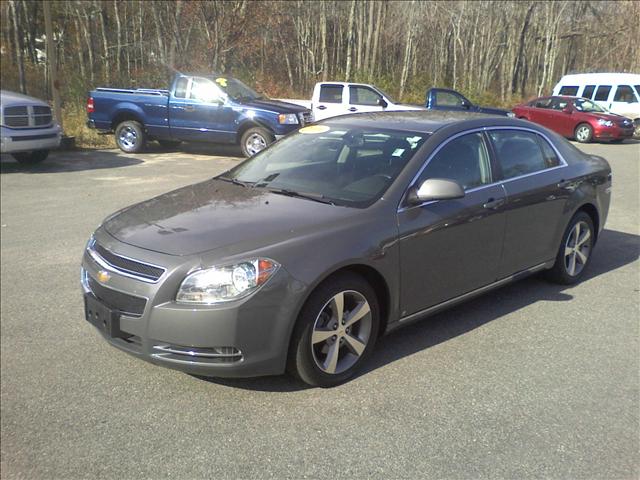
[398,133,505,316]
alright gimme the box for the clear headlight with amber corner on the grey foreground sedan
[176,258,280,305]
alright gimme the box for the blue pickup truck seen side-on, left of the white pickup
[87,74,311,157]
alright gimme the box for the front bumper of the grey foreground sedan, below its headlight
[82,229,303,377]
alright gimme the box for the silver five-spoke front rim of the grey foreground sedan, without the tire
[311,290,372,375]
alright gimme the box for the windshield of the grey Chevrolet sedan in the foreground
[218,124,427,208]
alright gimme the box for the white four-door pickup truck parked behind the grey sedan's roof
[281,82,426,121]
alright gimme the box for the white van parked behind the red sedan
[553,73,640,137]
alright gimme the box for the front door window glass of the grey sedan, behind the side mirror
[419,133,492,190]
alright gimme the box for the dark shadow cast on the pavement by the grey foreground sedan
[198,230,640,392]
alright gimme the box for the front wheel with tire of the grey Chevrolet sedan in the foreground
[287,274,380,387]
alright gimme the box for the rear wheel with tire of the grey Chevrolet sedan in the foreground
[549,212,595,285]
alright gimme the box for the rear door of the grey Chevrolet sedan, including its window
[487,128,572,278]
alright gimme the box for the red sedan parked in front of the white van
[512,97,633,143]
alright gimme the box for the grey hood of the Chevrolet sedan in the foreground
[103,179,358,255]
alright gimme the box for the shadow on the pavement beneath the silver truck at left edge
[0,150,144,174]
